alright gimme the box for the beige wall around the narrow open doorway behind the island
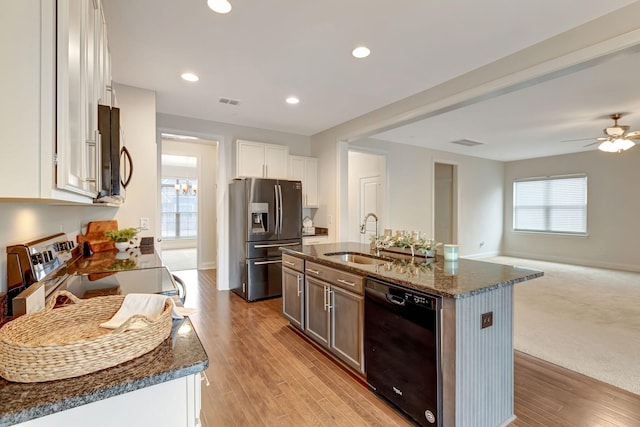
[350,139,504,257]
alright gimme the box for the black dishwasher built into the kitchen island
[364,279,442,426]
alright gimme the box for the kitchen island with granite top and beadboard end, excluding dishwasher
[282,243,543,427]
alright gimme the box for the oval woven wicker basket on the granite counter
[0,291,173,383]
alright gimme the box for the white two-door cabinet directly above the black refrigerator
[236,139,289,179]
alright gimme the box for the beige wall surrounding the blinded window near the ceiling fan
[503,147,640,271]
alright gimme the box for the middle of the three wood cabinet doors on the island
[304,276,329,347]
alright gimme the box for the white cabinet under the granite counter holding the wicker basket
[17,374,202,427]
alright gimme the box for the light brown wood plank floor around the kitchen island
[176,270,640,427]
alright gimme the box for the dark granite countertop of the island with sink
[281,243,543,298]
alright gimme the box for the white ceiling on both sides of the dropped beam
[103,0,640,160]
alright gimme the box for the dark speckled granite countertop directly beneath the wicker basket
[0,318,209,427]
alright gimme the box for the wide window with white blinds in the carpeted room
[513,175,587,234]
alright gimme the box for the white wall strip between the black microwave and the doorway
[114,84,160,241]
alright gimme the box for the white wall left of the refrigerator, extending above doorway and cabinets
[157,113,310,290]
